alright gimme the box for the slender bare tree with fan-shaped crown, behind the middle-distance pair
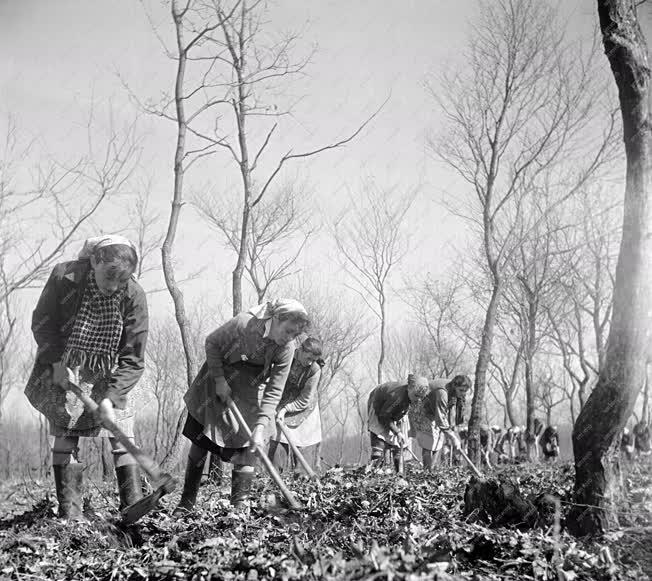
[333,183,416,383]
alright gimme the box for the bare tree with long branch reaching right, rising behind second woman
[136,0,376,314]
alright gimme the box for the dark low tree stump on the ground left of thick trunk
[464,476,538,528]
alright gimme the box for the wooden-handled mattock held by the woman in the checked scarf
[68,368,177,524]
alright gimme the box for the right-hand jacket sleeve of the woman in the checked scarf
[106,287,149,405]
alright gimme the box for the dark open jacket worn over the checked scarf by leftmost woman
[32,260,149,409]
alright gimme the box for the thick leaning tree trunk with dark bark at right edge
[566,0,652,535]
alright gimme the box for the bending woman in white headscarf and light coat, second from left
[175,299,309,514]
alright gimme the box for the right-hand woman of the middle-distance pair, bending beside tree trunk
[408,375,471,470]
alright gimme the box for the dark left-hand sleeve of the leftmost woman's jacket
[32,266,65,365]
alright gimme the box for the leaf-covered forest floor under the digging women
[0,465,652,581]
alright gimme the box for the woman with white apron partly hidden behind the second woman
[269,337,324,471]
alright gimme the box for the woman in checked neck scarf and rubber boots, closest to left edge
[25,236,148,520]
